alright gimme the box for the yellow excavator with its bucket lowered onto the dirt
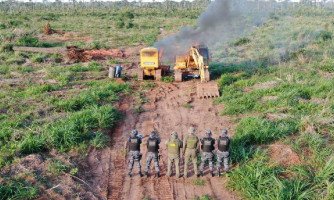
[174,45,219,98]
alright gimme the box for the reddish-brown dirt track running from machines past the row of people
[83,81,238,200]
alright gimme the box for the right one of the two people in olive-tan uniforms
[183,127,199,177]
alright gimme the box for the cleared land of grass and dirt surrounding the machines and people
[0,0,334,200]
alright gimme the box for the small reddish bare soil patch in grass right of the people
[268,143,301,167]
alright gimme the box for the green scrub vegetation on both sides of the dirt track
[0,1,334,200]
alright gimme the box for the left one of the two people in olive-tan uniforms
[166,131,182,178]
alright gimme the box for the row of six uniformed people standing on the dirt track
[126,127,230,178]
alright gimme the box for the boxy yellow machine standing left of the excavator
[138,47,169,81]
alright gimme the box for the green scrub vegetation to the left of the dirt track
[0,2,205,199]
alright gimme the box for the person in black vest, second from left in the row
[145,131,160,177]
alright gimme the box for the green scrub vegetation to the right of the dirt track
[213,7,334,199]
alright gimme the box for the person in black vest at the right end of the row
[217,129,230,176]
